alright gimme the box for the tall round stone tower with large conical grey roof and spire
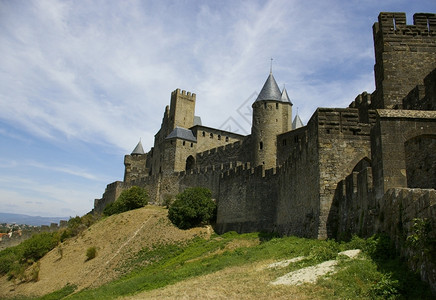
[251,73,292,169]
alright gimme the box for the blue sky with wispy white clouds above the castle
[0,0,436,216]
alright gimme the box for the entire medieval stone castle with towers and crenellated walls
[94,13,436,268]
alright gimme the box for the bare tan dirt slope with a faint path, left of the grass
[0,206,212,298]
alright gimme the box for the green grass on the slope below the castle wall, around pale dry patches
[23,232,431,299]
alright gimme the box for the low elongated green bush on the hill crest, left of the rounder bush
[103,186,149,216]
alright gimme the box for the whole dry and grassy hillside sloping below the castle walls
[0,206,432,300]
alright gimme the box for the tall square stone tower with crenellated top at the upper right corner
[372,13,436,108]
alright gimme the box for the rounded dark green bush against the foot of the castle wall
[168,187,216,229]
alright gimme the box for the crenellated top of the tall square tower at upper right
[373,12,436,36]
